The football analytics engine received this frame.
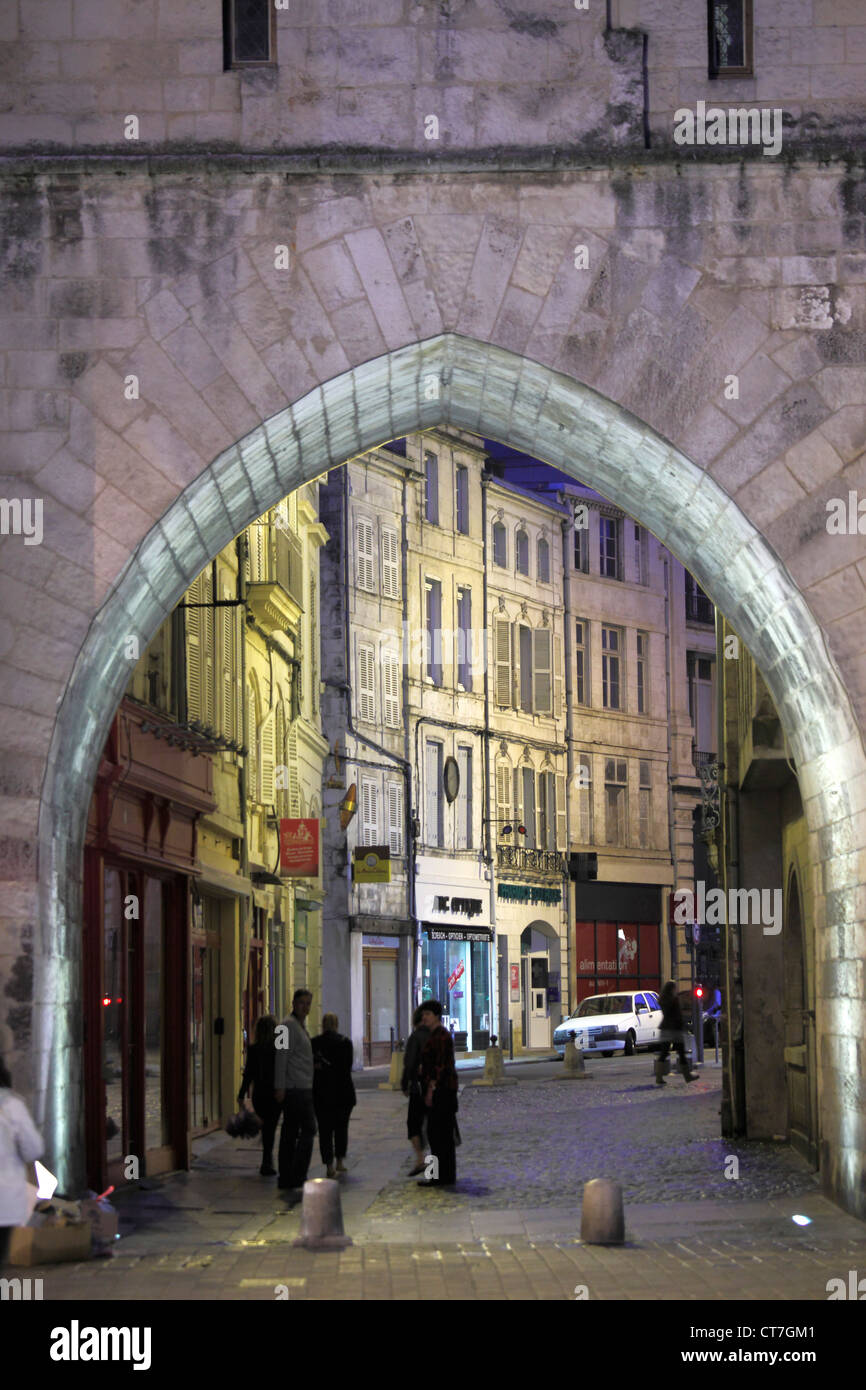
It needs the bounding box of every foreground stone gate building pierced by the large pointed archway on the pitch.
[0,0,866,1213]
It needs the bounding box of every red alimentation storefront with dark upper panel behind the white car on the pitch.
[574,883,662,1006]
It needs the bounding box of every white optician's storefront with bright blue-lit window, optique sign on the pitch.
[416,859,493,1052]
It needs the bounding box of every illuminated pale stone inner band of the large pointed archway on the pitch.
[33,334,866,1209]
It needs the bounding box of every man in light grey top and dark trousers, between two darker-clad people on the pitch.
[274,990,316,1201]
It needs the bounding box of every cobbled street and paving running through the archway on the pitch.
[32,1054,866,1301]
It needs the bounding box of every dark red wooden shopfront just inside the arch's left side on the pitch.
[83,699,215,1191]
